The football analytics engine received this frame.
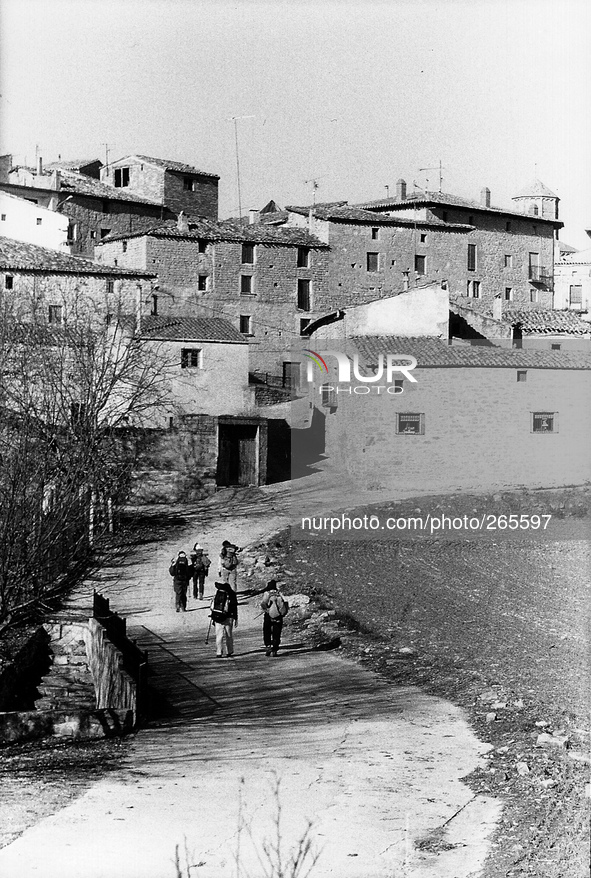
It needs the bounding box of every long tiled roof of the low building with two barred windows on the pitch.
[352,336,591,369]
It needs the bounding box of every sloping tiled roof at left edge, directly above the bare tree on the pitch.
[0,237,156,277]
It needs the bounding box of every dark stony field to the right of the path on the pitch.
[258,489,591,878]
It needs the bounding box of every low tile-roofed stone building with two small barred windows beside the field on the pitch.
[299,336,591,493]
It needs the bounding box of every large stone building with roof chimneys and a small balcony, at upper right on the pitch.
[280,180,562,310]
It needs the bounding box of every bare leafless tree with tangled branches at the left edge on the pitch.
[0,292,168,630]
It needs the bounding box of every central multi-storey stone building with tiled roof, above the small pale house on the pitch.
[96,216,328,384]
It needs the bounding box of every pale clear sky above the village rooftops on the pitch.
[0,0,591,249]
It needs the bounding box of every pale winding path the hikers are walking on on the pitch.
[0,490,500,878]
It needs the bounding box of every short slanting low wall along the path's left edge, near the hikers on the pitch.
[84,619,137,723]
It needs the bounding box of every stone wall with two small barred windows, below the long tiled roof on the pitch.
[324,367,591,492]
